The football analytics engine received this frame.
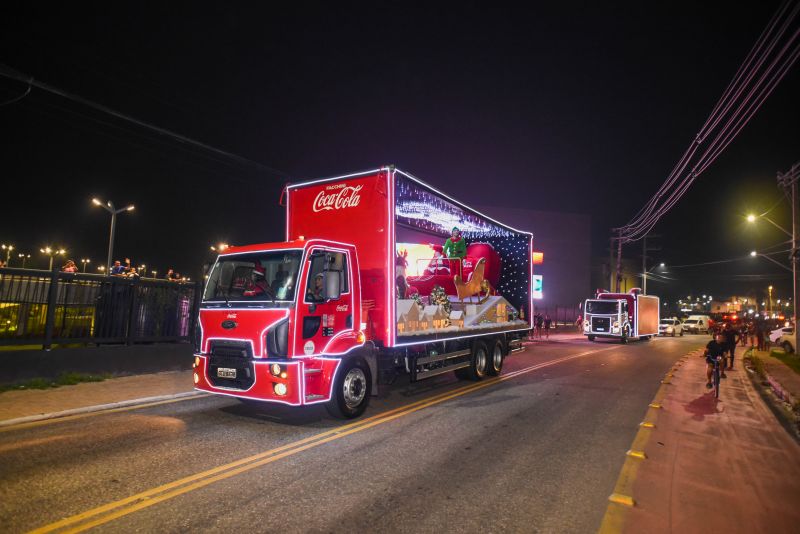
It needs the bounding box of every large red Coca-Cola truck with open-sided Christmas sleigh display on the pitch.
[194,167,532,417]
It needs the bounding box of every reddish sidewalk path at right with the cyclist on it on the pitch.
[604,351,800,534]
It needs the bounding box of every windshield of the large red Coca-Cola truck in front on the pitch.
[203,250,302,302]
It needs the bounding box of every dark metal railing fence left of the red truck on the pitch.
[0,269,202,349]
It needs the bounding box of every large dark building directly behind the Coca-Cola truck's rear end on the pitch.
[477,206,593,318]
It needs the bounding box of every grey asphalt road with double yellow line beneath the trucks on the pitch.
[0,336,706,532]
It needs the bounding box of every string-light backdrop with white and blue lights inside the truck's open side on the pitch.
[395,173,531,315]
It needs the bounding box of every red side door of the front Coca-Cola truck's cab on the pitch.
[294,248,354,356]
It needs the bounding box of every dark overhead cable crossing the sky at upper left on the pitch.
[0,63,290,178]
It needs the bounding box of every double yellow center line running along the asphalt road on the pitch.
[31,347,617,534]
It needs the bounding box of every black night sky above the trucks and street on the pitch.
[0,1,800,306]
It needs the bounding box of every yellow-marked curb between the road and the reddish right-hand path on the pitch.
[598,349,703,534]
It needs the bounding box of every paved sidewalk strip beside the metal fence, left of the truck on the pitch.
[0,371,194,424]
